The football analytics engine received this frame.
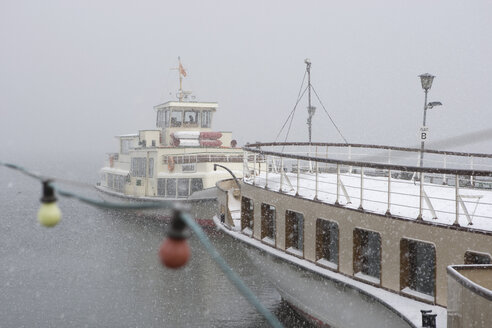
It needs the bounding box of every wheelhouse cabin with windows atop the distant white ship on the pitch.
[154,101,218,146]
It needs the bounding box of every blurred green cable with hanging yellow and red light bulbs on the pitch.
[0,161,283,328]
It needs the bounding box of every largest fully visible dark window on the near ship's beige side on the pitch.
[400,239,436,297]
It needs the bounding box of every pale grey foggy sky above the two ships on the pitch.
[0,0,492,161]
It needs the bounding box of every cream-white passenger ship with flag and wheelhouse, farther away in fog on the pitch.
[98,61,243,200]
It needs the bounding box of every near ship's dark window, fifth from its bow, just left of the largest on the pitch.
[354,229,381,284]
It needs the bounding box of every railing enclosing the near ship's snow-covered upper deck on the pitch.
[243,143,492,230]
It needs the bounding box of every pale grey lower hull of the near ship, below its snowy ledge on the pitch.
[246,246,414,328]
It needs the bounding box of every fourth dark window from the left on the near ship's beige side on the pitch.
[316,219,338,266]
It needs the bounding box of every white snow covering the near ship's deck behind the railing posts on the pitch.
[244,171,492,231]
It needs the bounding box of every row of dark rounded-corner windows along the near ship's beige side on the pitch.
[241,197,491,297]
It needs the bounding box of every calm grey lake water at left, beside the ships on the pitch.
[0,156,310,327]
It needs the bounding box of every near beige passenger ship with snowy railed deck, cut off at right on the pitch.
[214,60,492,328]
